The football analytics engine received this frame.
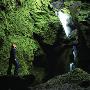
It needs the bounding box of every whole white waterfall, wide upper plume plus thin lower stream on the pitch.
[55,10,77,71]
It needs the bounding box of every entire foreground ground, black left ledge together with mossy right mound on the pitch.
[0,68,90,90]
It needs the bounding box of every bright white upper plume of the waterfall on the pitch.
[55,10,72,37]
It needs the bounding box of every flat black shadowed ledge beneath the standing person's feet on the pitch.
[0,75,35,90]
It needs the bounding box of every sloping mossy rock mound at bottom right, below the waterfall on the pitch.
[29,69,90,90]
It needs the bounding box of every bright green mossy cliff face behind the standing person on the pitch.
[0,0,89,81]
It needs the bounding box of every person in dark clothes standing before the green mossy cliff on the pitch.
[7,44,19,76]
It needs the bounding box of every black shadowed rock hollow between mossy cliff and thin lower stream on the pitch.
[33,31,71,80]
